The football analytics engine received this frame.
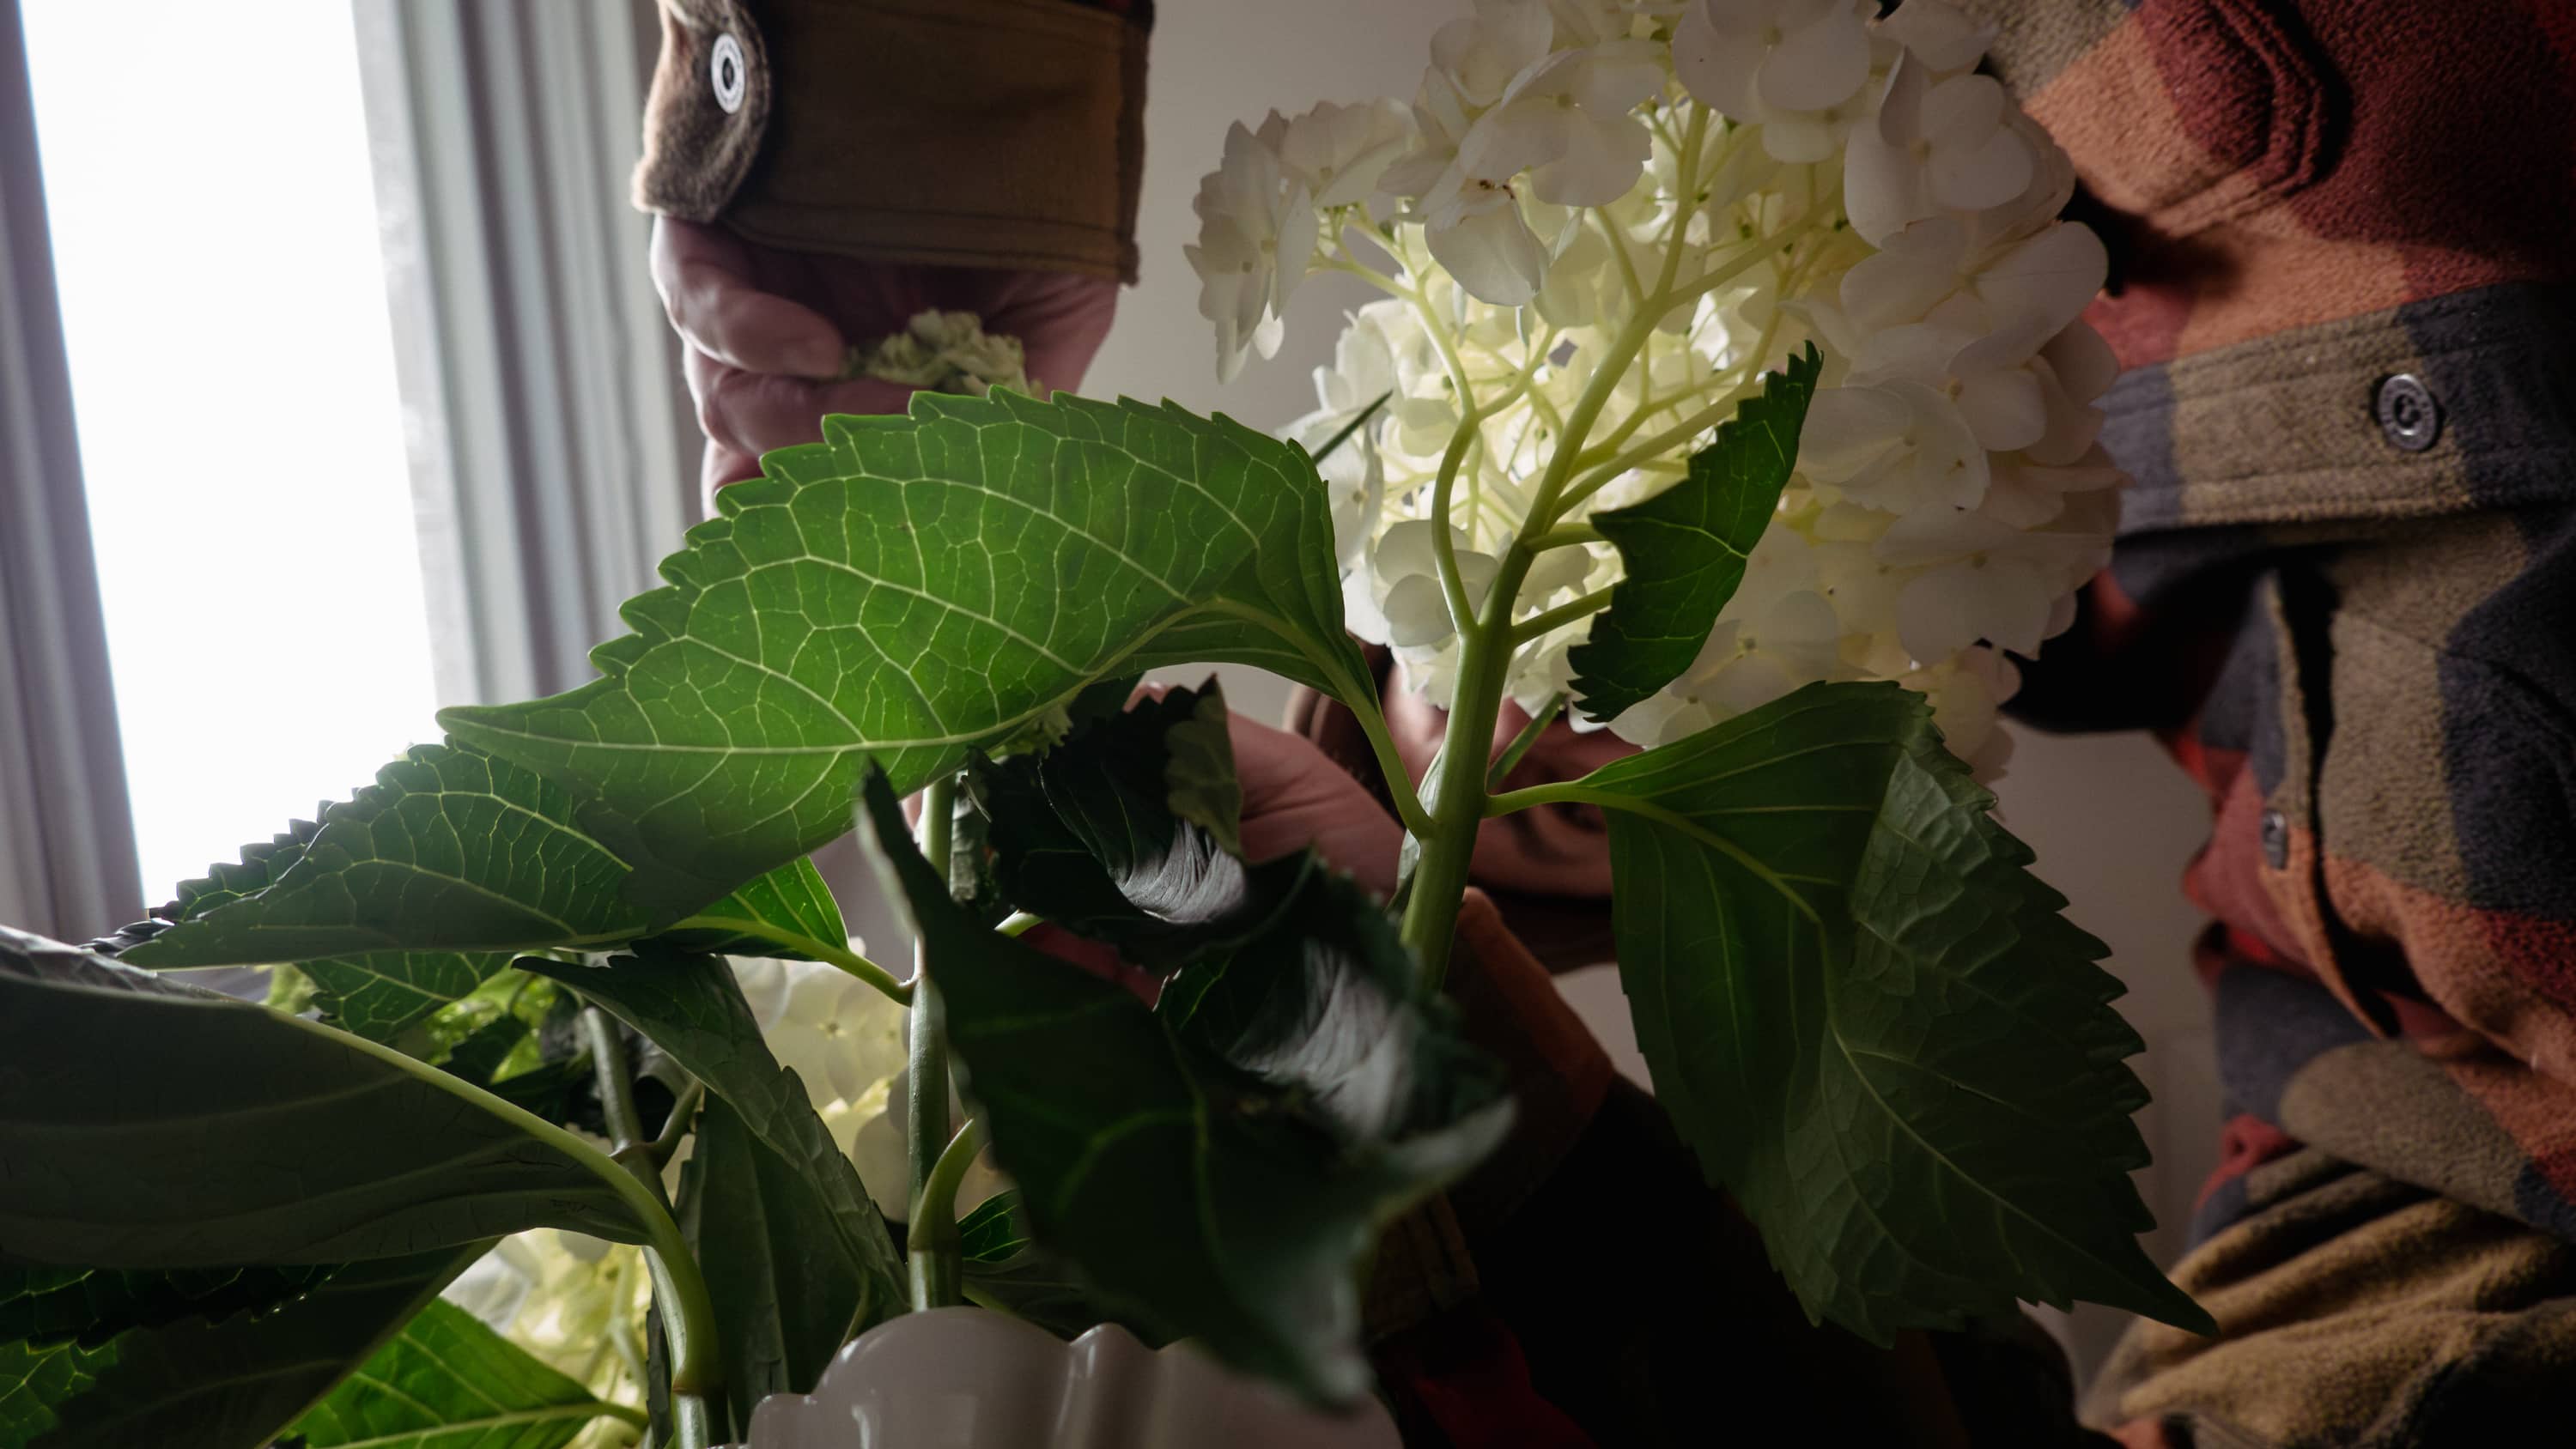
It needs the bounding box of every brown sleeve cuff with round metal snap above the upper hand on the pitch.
[634,0,1151,281]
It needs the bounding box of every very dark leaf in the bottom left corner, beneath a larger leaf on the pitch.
[0,1243,484,1449]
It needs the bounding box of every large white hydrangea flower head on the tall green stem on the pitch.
[1188,0,2123,777]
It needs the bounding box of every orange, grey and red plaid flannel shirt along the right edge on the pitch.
[1971,0,2576,1446]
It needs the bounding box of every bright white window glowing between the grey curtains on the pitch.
[21,0,435,900]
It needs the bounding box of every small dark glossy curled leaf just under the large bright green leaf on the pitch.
[971,685,1309,970]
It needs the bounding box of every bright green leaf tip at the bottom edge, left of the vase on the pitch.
[291,1300,626,1449]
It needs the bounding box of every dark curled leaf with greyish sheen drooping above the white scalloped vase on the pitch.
[866,774,1510,1403]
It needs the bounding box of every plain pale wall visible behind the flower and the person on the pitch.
[1084,0,2218,1361]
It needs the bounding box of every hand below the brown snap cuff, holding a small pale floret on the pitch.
[652,216,1118,500]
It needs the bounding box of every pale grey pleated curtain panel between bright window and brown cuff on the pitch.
[355,0,698,703]
